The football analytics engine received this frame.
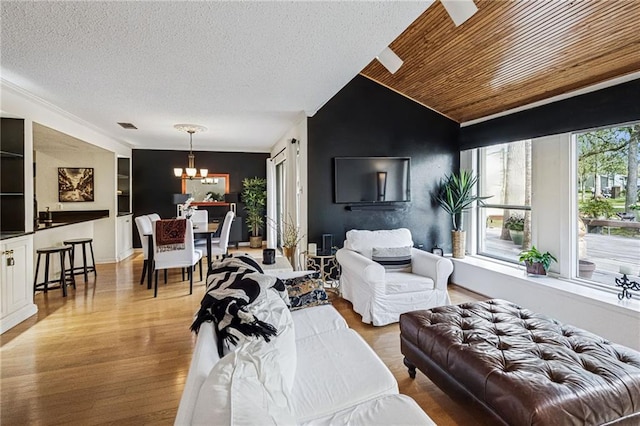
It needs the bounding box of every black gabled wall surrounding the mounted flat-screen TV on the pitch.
[307,75,460,250]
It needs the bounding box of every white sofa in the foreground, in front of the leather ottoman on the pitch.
[175,305,435,426]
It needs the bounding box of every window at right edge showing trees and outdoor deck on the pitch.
[573,123,640,287]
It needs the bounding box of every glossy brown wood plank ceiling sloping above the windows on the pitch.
[361,0,640,123]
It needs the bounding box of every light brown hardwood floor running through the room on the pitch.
[0,250,488,425]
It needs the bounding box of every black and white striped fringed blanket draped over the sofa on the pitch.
[191,256,289,356]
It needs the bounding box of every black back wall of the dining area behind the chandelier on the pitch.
[131,149,269,247]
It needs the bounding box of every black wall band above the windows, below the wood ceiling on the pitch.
[460,79,640,149]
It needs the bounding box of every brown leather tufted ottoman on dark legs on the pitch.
[400,299,640,426]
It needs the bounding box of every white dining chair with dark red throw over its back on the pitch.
[153,219,202,297]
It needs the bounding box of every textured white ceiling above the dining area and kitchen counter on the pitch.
[0,1,432,151]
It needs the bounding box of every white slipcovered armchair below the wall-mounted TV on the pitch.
[336,228,453,325]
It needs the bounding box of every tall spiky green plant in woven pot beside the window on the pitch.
[435,170,489,259]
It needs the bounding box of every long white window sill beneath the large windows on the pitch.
[451,256,640,319]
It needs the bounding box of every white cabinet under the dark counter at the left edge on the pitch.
[0,235,38,333]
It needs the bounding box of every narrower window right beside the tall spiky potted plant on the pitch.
[477,140,531,262]
